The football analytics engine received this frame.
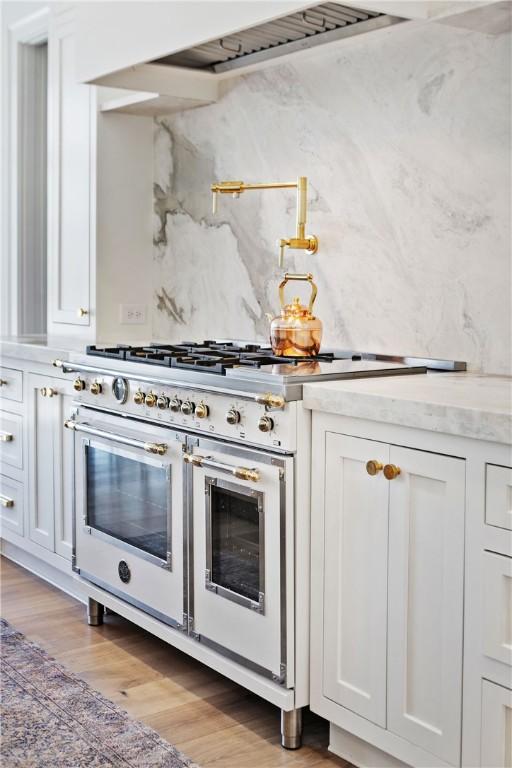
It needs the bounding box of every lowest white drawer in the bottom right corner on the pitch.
[480,680,512,768]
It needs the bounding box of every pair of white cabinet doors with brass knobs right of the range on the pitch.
[311,415,466,766]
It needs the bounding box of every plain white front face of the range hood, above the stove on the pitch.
[77,0,311,83]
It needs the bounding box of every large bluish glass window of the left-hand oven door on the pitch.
[85,445,171,566]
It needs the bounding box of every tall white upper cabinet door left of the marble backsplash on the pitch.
[48,13,92,333]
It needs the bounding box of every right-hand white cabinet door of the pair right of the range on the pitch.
[388,446,465,765]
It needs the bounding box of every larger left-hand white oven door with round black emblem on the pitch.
[67,408,185,626]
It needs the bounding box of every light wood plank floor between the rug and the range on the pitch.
[0,558,348,768]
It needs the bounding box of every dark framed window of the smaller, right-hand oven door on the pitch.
[205,477,265,613]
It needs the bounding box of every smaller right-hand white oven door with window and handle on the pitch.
[184,438,294,687]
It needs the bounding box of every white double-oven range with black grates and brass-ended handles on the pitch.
[55,341,464,748]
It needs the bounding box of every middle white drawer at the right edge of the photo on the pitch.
[482,552,512,666]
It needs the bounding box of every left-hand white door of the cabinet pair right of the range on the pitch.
[323,433,389,727]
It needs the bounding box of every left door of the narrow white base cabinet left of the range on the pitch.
[28,373,55,551]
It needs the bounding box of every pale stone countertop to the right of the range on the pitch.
[304,373,512,444]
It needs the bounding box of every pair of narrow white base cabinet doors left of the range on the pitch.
[27,373,73,559]
